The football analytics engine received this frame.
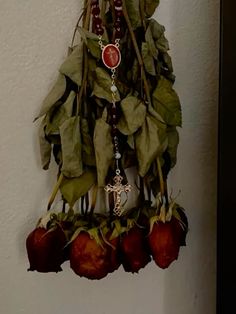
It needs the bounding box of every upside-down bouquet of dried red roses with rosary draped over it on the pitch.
[26,0,188,279]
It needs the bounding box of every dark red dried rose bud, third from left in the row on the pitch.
[121,226,151,273]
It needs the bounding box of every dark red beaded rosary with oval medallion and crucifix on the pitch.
[91,0,131,216]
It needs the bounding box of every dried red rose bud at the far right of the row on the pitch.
[148,217,183,269]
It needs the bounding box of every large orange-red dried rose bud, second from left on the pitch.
[70,231,109,279]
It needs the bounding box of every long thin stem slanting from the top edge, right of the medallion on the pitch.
[123,0,152,105]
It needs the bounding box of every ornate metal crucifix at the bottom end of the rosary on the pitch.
[104,175,131,216]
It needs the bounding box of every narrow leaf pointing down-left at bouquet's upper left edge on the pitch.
[35,74,66,120]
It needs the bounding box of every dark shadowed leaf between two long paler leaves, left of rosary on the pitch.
[80,119,96,166]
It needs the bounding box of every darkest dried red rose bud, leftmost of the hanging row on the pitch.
[26,227,66,273]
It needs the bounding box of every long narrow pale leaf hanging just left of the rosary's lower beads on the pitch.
[94,112,113,187]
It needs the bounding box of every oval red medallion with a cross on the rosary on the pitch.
[102,44,121,69]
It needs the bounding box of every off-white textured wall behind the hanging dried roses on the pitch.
[0,0,219,314]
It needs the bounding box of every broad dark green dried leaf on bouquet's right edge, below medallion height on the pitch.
[152,76,182,126]
